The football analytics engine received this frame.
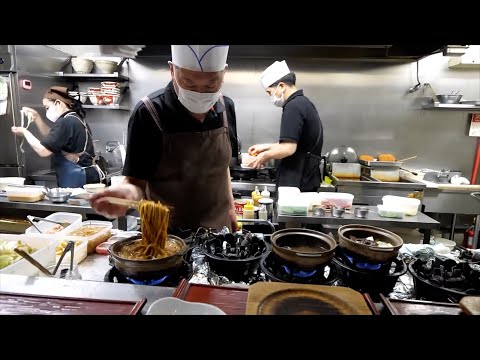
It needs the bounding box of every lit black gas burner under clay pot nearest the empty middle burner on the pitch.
[260,251,338,285]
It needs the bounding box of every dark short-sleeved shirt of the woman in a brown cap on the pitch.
[40,111,99,183]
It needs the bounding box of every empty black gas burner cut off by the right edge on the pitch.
[408,257,480,302]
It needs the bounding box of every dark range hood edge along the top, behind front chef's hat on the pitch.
[134,44,446,62]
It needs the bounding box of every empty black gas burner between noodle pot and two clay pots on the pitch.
[202,234,270,282]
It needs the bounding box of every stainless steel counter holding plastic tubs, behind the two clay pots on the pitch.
[277,206,440,244]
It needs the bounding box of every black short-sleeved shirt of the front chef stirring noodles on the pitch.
[123,81,238,180]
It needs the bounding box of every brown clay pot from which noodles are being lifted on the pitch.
[109,235,188,279]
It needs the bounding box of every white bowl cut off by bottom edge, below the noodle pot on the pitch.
[147,297,226,315]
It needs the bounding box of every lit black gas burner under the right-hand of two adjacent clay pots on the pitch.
[333,253,407,301]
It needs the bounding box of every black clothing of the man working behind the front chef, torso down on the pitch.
[277,90,323,191]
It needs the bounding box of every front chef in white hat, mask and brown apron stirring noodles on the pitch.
[91,45,238,234]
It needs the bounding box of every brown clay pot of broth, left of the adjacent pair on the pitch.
[271,228,337,269]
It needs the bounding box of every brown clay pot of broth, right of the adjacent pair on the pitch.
[338,225,403,263]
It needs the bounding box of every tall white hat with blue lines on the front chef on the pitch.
[172,45,228,72]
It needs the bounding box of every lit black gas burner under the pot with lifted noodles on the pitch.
[103,261,193,287]
